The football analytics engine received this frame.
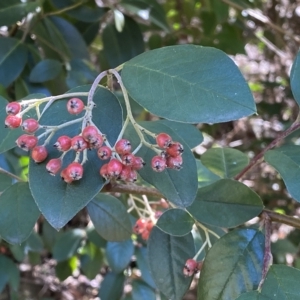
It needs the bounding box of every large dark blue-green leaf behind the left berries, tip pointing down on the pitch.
[29,86,122,229]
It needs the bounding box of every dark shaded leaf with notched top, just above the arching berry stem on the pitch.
[102,17,145,68]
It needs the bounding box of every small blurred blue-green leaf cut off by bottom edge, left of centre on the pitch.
[99,272,125,300]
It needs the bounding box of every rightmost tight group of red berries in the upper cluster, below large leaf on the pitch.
[151,133,183,172]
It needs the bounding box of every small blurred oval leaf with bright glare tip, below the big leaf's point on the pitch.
[52,228,86,262]
